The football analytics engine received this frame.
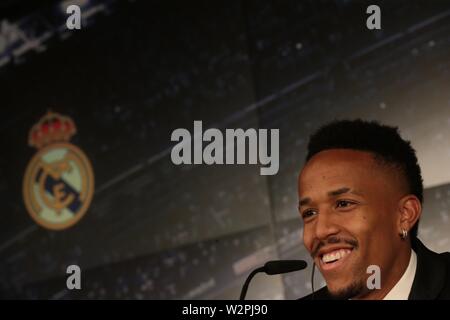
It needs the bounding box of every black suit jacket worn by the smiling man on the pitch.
[301,239,450,300]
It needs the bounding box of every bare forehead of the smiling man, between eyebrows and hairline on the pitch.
[298,149,389,194]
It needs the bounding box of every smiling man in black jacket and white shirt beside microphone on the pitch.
[298,120,450,300]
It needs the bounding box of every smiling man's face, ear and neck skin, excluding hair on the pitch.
[298,149,422,299]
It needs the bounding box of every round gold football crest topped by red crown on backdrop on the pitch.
[23,112,94,230]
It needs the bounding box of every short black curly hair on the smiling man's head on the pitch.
[306,119,423,238]
